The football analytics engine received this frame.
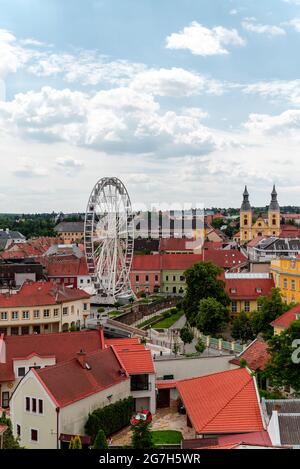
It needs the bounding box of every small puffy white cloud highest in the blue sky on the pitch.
[166,21,246,56]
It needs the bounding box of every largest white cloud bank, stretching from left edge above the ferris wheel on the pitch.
[0,87,235,156]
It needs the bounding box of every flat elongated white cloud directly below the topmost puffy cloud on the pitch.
[130,67,223,97]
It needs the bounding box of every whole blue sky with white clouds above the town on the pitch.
[0,0,300,212]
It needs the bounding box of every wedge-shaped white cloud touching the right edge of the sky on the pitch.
[242,79,300,106]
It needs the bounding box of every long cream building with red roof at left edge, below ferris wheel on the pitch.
[0,282,90,335]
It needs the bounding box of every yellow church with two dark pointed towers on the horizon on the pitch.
[240,185,280,244]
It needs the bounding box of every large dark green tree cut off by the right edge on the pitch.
[264,320,300,393]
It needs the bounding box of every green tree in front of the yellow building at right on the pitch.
[251,288,291,339]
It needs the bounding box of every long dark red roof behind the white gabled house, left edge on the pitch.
[0,331,101,382]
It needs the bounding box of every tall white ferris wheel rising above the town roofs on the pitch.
[84,177,134,303]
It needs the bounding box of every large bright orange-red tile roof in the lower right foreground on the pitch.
[177,368,264,434]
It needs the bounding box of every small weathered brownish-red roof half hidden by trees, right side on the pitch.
[230,338,270,371]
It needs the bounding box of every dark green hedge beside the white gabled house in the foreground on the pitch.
[85,396,134,442]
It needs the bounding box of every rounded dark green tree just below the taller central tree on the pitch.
[196,298,229,335]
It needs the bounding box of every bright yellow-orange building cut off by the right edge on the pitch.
[270,257,300,303]
